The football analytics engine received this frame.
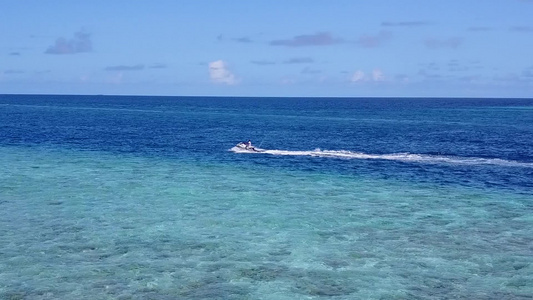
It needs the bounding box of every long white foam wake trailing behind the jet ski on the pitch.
[230,147,533,168]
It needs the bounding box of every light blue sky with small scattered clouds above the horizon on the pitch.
[0,0,533,98]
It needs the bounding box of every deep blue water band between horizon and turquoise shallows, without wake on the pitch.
[0,95,533,191]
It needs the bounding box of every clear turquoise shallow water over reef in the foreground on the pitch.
[0,146,533,299]
